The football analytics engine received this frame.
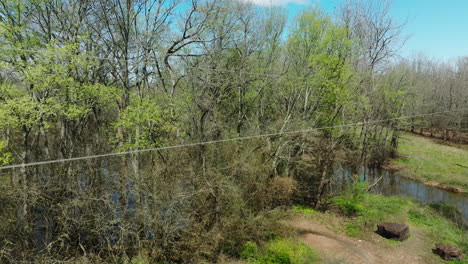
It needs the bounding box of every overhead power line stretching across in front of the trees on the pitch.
[0,109,464,170]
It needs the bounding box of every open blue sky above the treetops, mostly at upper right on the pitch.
[244,0,468,60]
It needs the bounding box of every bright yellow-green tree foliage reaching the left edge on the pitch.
[0,43,120,134]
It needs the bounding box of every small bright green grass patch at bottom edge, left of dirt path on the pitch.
[241,238,318,264]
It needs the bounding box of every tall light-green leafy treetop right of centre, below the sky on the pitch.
[288,8,363,128]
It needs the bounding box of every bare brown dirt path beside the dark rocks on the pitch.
[287,217,440,264]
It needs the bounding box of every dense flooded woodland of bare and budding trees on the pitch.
[0,0,468,263]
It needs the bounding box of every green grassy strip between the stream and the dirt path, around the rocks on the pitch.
[294,185,468,256]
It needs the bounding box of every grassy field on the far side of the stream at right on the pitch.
[393,133,468,191]
